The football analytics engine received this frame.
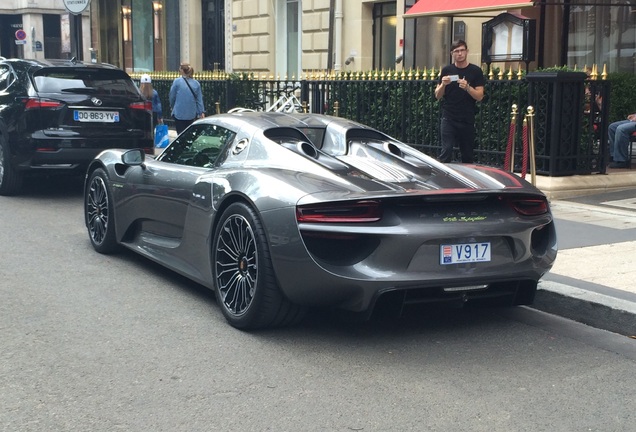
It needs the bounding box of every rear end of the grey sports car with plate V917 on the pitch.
[277,192,556,311]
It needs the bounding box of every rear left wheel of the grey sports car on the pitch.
[213,203,304,330]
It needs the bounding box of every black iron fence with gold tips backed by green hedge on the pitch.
[139,71,610,176]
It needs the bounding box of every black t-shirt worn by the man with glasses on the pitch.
[440,63,486,123]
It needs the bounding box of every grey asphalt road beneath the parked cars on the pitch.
[0,176,636,432]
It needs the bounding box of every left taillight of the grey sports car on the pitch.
[296,200,382,223]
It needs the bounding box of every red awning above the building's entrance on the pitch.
[404,0,534,18]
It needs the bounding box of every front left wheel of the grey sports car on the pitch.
[84,168,119,254]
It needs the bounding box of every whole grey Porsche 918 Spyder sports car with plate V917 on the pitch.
[84,112,557,329]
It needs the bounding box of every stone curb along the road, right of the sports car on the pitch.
[530,281,636,337]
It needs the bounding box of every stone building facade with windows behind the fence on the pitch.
[0,0,636,78]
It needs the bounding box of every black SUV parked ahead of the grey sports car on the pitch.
[0,57,154,195]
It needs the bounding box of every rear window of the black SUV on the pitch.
[33,68,139,96]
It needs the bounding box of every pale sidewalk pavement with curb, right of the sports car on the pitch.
[532,176,636,338]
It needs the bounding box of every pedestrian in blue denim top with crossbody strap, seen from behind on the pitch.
[170,63,205,134]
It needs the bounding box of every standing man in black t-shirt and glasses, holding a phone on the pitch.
[435,40,486,163]
